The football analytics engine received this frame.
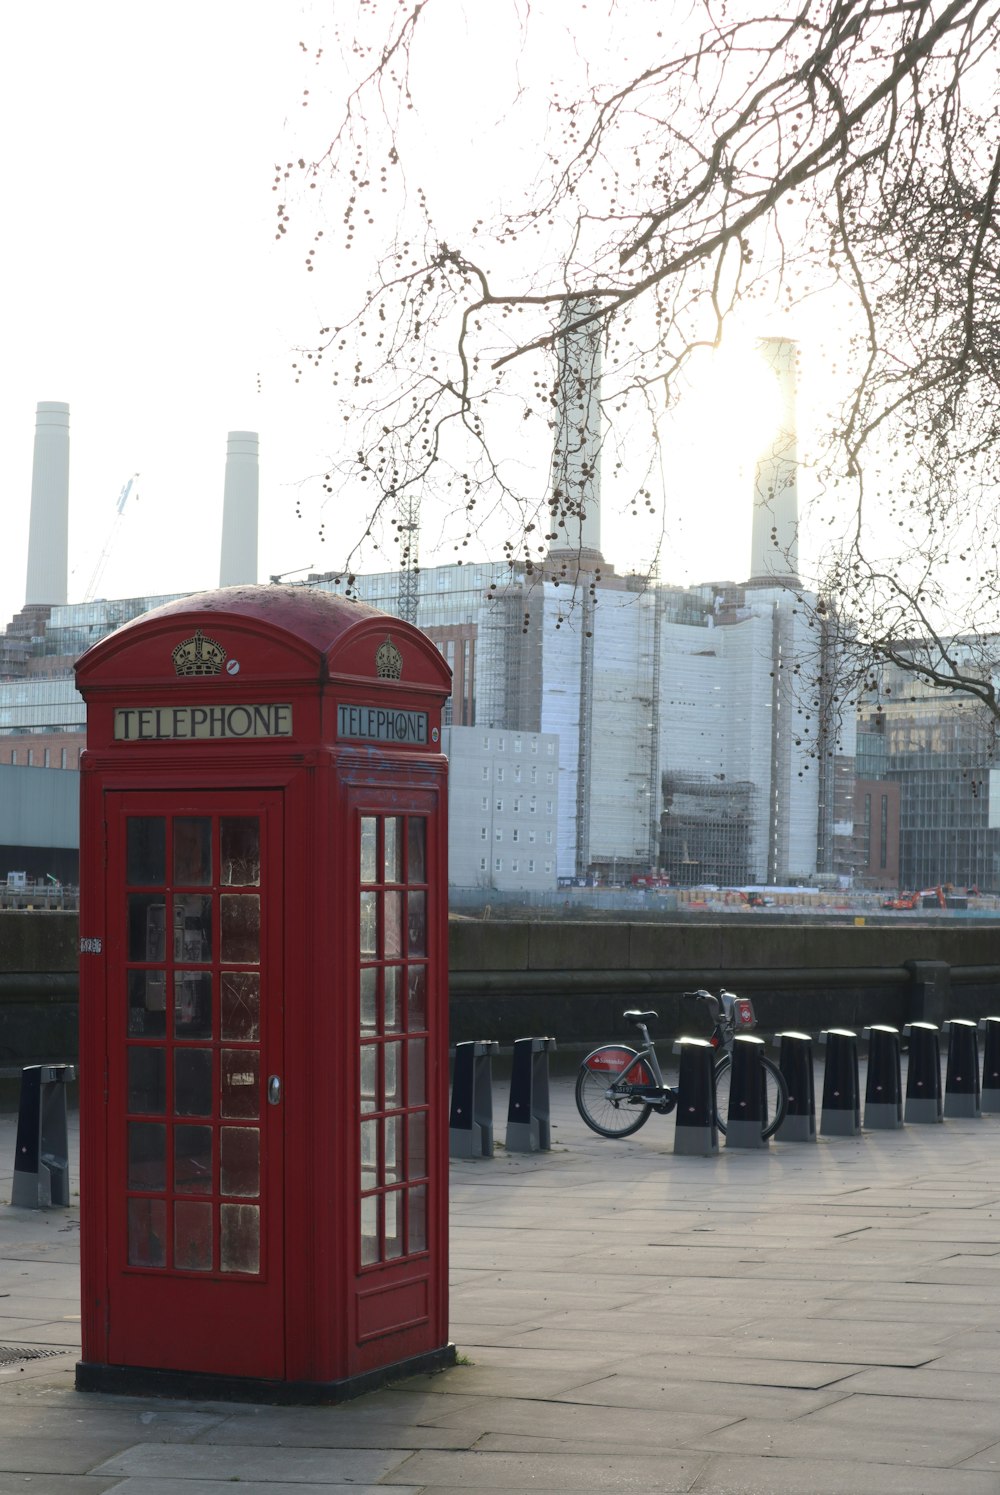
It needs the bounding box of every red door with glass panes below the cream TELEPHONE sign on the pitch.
[105,789,284,1378]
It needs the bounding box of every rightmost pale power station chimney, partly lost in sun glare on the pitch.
[750,338,800,588]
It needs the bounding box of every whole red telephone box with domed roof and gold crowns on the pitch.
[76,586,454,1401]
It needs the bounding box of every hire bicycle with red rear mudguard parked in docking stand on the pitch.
[575,988,788,1138]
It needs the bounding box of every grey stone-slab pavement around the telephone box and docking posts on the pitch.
[0,1079,1000,1495]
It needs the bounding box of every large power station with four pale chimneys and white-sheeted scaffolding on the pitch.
[0,346,855,888]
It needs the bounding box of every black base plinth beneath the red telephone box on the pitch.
[76,1344,456,1407]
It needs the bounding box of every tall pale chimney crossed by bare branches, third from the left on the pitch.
[549,296,604,559]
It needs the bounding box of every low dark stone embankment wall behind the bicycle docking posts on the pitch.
[0,912,1000,1073]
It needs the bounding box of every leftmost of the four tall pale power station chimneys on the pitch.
[24,399,69,605]
